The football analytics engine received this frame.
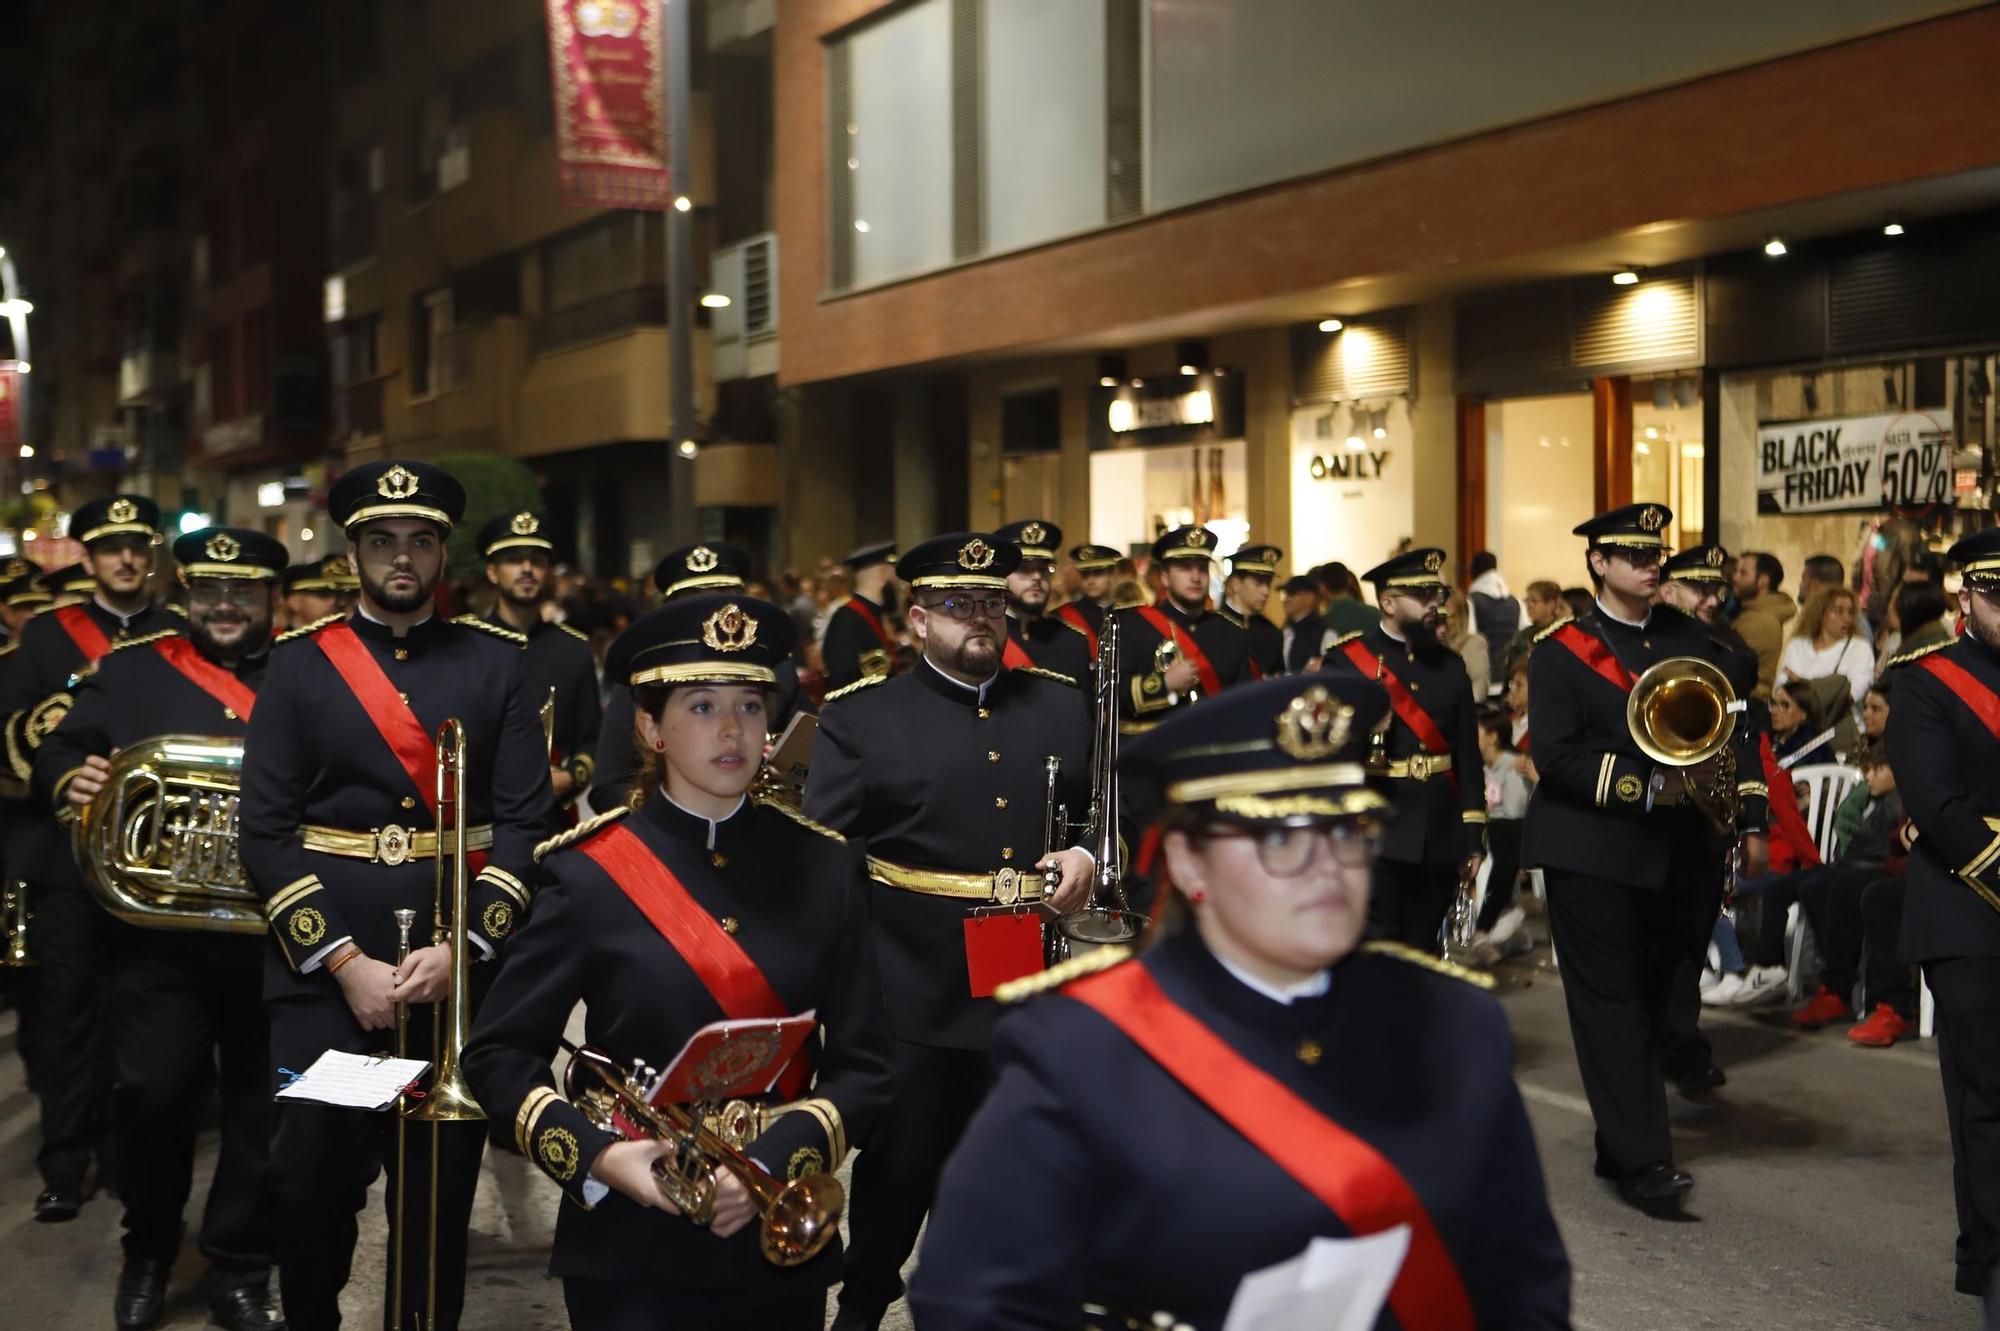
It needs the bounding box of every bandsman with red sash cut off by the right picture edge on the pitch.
[1880,528,2000,1295]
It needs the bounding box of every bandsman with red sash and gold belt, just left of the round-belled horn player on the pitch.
[1326,548,1486,953]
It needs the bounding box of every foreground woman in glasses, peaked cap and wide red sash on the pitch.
[912,673,1570,1331]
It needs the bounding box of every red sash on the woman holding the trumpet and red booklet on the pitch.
[576,825,810,1099]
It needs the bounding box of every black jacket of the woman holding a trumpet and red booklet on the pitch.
[464,791,892,1293]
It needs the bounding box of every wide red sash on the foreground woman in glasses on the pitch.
[1064,965,1474,1331]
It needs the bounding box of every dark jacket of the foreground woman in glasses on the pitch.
[910,929,1570,1331]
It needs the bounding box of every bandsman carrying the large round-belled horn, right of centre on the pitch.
[1522,504,1764,1213]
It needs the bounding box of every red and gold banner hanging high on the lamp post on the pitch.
[546,0,672,212]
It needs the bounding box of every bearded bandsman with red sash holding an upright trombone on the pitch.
[240,462,556,1331]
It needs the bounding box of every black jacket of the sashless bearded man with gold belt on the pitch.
[806,662,1090,1049]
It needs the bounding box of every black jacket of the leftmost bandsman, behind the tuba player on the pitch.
[0,598,182,889]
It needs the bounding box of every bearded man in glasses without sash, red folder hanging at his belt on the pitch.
[806,532,1092,1329]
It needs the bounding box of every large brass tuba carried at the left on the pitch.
[70,735,264,933]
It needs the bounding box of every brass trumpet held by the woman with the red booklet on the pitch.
[562,1041,846,1267]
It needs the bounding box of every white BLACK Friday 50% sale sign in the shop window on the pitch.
[1756,412,1952,514]
